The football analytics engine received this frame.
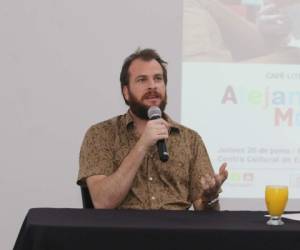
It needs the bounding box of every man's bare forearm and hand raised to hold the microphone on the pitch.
[86,119,168,208]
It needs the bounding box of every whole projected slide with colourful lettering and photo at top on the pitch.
[181,0,300,198]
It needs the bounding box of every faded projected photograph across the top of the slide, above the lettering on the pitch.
[183,0,300,64]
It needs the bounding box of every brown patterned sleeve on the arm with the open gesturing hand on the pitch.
[190,133,214,202]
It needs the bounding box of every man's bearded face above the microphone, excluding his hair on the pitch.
[123,59,167,120]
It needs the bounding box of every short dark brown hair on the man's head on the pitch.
[120,49,168,105]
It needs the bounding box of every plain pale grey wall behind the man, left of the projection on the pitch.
[0,0,182,249]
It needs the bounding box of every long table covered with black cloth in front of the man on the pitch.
[14,208,300,250]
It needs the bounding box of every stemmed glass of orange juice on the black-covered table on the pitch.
[265,185,289,226]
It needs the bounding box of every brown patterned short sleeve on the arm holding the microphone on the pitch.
[77,126,113,186]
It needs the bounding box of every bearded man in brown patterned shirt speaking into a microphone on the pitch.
[78,49,228,210]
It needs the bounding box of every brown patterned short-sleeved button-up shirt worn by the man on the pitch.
[77,112,213,210]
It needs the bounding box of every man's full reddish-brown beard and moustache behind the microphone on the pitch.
[128,90,167,120]
